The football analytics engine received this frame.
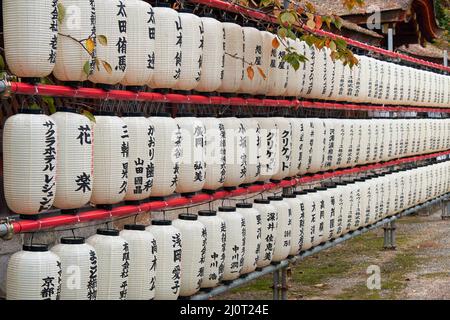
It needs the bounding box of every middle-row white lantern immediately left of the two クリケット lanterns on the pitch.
[240,117,261,184]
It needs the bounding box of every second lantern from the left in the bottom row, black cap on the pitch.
[52,237,98,300]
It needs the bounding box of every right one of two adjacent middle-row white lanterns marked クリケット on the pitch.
[272,117,292,180]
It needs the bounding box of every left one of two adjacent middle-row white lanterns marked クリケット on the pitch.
[256,117,279,181]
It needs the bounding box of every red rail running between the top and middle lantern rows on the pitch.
[10,82,450,113]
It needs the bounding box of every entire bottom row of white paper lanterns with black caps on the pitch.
[7,161,450,299]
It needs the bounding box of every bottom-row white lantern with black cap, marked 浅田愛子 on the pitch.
[146,220,182,300]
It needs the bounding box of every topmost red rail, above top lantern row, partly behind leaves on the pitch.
[189,0,450,72]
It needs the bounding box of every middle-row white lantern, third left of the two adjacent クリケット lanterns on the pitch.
[199,114,227,190]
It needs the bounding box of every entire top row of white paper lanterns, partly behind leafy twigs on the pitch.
[3,0,450,107]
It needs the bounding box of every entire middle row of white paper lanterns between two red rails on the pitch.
[3,109,450,214]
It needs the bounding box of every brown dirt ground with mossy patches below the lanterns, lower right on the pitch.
[218,205,450,300]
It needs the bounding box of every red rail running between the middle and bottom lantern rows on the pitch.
[12,150,450,233]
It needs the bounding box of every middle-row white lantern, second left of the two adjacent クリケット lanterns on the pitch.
[222,117,248,188]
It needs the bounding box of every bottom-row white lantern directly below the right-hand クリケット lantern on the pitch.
[267,196,292,262]
